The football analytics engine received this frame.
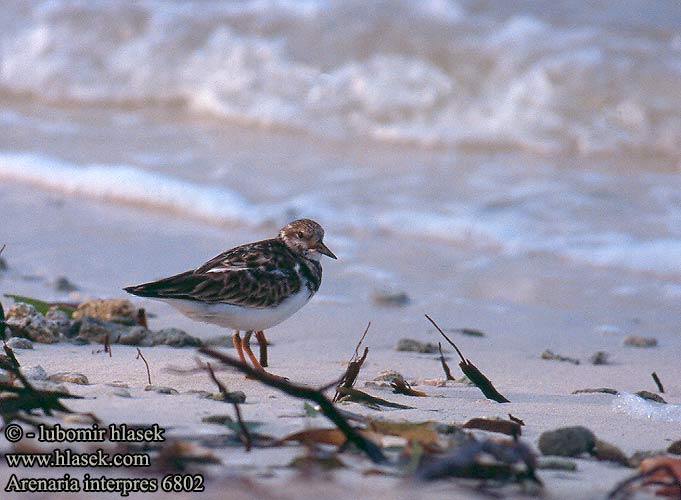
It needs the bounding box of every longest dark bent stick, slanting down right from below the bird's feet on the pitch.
[199,347,387,463]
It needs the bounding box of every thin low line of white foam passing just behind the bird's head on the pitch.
[0,152,681,277]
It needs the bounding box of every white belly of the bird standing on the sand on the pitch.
[158,287,310,331]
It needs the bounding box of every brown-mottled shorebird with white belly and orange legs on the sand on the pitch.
[124,219,337,376]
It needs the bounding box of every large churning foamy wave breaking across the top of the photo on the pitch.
[0,0,681,154]
